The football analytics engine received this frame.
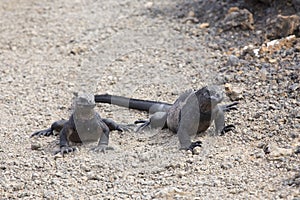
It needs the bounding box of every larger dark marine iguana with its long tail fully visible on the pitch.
[95,86,238,151]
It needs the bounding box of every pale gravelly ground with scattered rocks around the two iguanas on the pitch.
[0,0,300,200]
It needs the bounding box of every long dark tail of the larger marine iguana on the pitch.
[95,94,172,113]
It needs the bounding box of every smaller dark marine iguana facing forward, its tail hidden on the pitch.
[31,94,127,155]
